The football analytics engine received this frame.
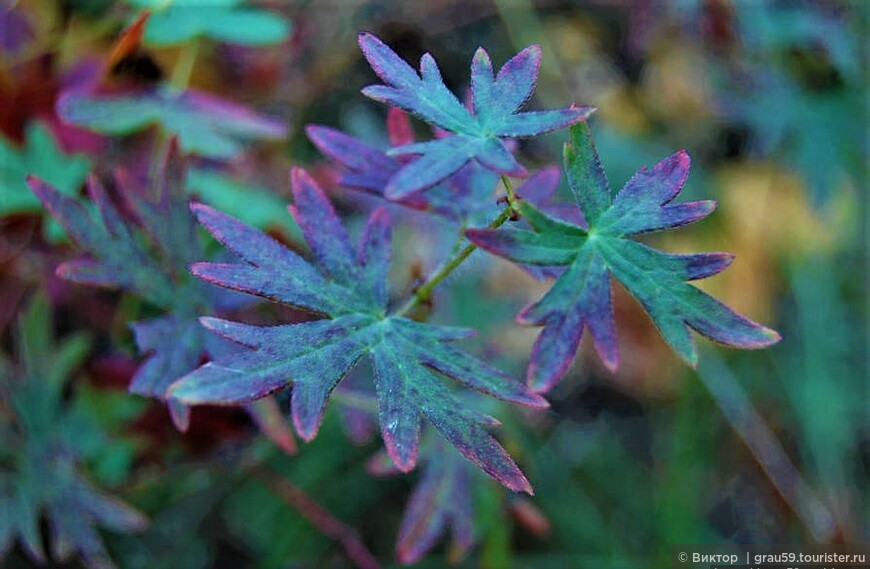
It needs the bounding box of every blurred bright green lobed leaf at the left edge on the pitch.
[0,122,91,237]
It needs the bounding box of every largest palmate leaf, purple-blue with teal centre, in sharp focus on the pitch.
[170,169,546,492]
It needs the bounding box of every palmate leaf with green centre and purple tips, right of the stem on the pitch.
[467,125,779,392]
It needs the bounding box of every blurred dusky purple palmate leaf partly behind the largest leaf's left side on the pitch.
[28,139,292,449]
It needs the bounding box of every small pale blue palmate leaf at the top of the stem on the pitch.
[359,33,594,199]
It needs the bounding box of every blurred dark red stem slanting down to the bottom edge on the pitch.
[258,470,380,569]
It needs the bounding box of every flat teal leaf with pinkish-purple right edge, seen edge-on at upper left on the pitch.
[57,87,287,159]
